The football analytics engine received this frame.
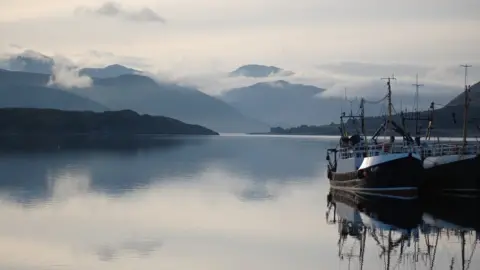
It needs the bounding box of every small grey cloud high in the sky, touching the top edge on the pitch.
[75,2,166,23]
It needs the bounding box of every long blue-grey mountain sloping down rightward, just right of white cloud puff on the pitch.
[73,74,269,132]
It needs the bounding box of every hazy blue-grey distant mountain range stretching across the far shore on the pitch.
[0,51,474,132]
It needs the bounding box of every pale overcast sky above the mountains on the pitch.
[0,0,480,95]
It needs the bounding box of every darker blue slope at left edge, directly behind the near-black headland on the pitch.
[0,70,108,112]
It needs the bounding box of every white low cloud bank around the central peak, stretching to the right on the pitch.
[149,61,480,113]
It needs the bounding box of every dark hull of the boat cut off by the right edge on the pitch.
[422,155,480,198]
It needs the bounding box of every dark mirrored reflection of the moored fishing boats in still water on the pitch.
[326,190,480,270]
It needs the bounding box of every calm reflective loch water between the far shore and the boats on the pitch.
[0,136,480,270]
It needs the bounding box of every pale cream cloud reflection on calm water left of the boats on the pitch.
[0,170,335,269]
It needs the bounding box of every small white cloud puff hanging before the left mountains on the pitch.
[48,56,93,88]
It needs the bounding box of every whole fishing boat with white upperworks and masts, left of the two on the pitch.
[327,77,423,199]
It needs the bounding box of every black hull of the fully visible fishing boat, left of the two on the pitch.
[330,155,423,199]
